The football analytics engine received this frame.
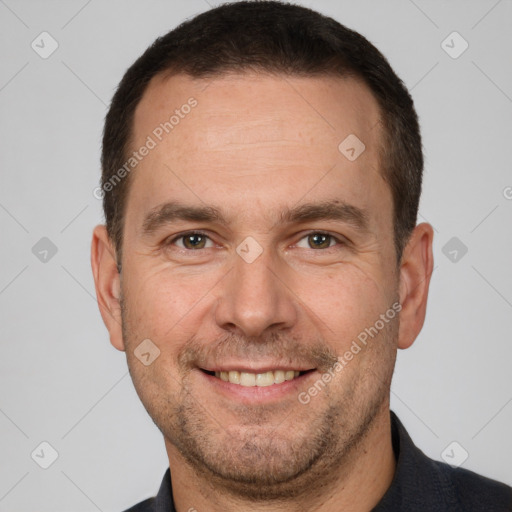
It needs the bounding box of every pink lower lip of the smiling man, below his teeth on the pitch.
[197,370,316,403]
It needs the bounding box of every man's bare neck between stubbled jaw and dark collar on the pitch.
[165,403,396,512]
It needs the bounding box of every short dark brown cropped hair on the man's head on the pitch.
[101,1,423,266]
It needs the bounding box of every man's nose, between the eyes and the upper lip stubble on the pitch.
[215,244,297,337]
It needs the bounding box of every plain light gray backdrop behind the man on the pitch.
[0,0,512,512]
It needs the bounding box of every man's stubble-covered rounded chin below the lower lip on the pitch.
[163,402,348,501]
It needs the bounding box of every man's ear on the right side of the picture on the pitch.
[398,222,434,349]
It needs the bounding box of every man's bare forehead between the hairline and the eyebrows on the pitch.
[127,73,389,231]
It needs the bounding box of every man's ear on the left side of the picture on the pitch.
[91,225,125,351]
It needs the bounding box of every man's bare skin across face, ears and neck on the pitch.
[91,74,433,512]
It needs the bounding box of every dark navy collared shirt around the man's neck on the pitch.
[126,411,512,512]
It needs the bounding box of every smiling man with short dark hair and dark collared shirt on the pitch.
[92,2,512,512]
